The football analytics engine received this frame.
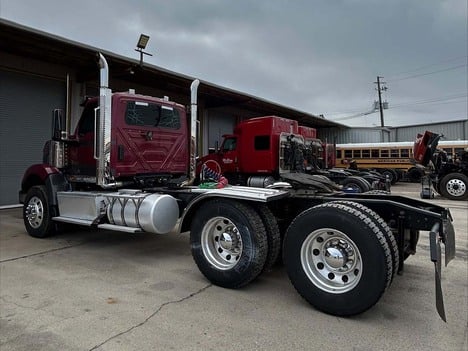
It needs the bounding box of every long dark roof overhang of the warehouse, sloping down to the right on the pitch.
[0,19,348,128]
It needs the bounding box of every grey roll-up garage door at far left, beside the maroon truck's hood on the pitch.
[0,70,66,206]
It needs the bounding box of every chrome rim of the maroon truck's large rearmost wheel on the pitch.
[301,228,362,294]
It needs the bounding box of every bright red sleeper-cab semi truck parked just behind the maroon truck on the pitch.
[197,116,390,192]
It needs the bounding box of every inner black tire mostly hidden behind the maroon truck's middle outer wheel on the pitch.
[255,204,281,272]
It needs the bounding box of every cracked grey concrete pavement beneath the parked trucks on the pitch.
[0,183,468,351]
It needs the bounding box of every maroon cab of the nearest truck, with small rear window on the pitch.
[45,91,189,186]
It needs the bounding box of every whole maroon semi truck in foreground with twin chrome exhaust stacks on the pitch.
[19,54,455,320]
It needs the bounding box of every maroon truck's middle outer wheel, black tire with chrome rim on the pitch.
[190,199,268,289]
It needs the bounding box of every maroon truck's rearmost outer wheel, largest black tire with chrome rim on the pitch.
[283,202,393,316]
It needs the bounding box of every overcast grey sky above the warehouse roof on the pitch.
[0,0,468,127]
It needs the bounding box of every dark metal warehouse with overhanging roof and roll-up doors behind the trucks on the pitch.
[0,19,347,206]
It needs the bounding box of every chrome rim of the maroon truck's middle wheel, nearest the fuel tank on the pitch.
[201,216,243,270]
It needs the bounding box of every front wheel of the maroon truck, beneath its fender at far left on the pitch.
[23,185,56,238]
